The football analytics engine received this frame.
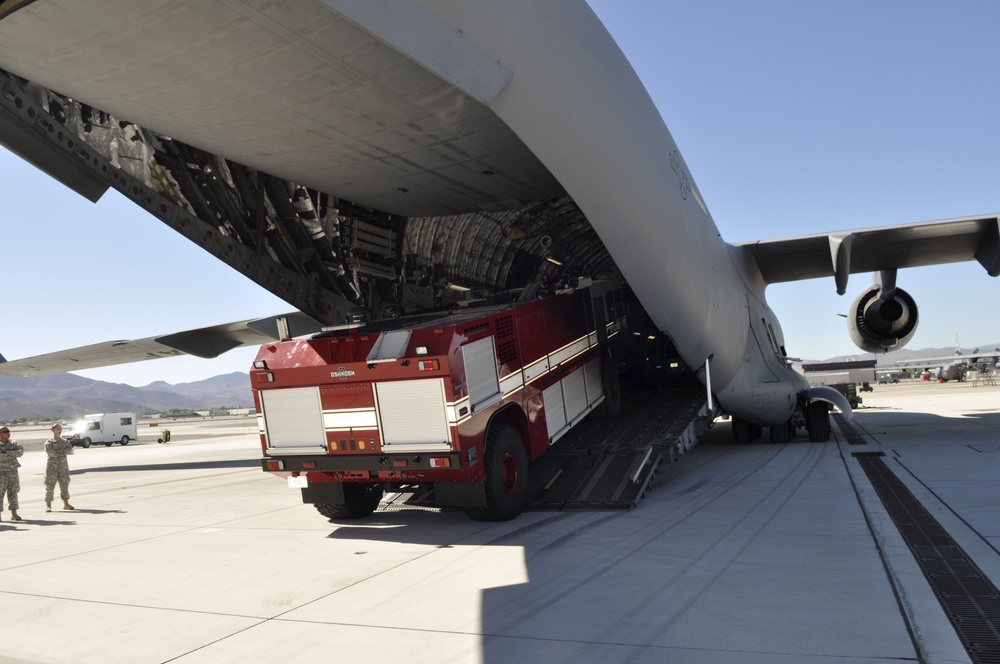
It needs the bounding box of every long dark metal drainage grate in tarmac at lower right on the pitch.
[852,452,1000,664]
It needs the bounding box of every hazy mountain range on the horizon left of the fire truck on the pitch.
[0,371,253,420]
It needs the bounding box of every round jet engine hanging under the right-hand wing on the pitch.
[847,284,917,353]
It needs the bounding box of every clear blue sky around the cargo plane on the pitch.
[0,0,1000,385]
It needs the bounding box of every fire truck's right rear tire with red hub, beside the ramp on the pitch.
[465,424,528,521]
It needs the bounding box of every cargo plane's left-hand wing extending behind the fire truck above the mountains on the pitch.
[0,312,321,376]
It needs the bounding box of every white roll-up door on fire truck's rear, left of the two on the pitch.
[260,387,327,454]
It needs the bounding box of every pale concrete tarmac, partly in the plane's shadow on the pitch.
[0,383,1000,664]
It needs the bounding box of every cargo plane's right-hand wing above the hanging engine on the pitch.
[737,215,1000,295]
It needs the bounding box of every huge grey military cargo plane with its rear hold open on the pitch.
[0,0,1000,442]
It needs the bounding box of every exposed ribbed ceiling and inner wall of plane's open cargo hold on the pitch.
[0,70,618,324]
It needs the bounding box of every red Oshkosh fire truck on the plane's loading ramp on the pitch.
[251,279,625,520]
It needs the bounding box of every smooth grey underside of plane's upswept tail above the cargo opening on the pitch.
[0,0,563,216]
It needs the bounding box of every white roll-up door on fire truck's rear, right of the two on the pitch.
[375,378,451,452]
